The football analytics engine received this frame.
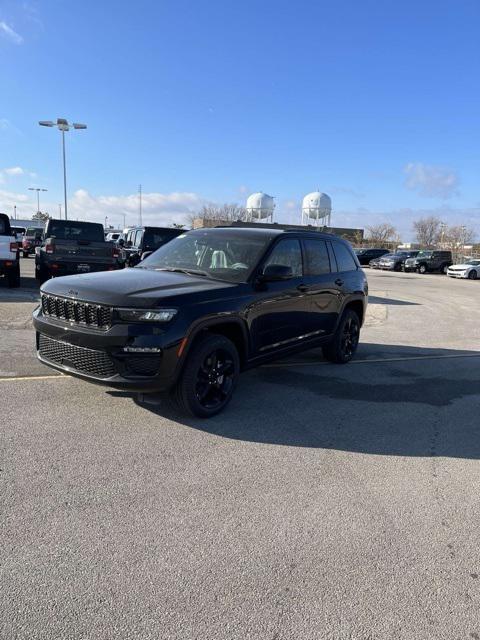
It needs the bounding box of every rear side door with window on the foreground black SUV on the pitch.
[302,238,342,337]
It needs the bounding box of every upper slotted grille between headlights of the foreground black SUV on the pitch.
[42,293,112,330]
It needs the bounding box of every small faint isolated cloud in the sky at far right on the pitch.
[404,162,459,199]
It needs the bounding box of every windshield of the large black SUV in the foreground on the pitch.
[139,229,270,282]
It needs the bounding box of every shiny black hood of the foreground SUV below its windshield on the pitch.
[41,268,238,307]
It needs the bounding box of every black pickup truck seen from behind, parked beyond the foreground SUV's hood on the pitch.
[35,220,120,283]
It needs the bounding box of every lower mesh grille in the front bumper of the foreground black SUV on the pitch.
[38,334,116,378]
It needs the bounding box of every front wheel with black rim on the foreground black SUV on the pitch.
[174,334,240,418]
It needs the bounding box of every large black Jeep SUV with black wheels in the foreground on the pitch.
[33,227,368,417]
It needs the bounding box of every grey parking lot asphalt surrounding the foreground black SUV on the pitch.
[0,259,480,640]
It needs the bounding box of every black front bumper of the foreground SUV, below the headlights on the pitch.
[33,308,183,391]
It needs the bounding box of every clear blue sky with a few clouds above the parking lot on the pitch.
[0,0,480,237]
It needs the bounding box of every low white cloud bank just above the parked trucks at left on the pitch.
[68,189,206,226]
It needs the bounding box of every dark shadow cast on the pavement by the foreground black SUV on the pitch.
[115,344,480,459]
